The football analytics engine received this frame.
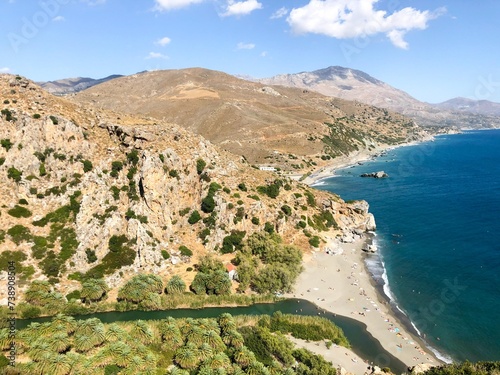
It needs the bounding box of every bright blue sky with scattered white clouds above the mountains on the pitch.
[0,0,500,103]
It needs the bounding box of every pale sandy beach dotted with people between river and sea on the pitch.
[287,240,442,374]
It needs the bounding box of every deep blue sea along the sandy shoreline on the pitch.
[317,130,500,361]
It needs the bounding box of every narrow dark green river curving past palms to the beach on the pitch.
[17,299,408,373]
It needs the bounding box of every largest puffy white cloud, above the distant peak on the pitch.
[287,0,446,49]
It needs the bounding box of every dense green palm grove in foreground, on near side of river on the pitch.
[0,313,349,375]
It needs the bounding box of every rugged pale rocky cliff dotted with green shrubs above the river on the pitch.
[0,75,375,299]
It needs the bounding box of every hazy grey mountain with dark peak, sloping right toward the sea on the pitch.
[258,66,500,128]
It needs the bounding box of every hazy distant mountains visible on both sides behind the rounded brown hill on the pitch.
[39,66,500,128]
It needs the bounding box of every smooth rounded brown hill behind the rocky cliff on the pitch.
[70,68,424,173]
